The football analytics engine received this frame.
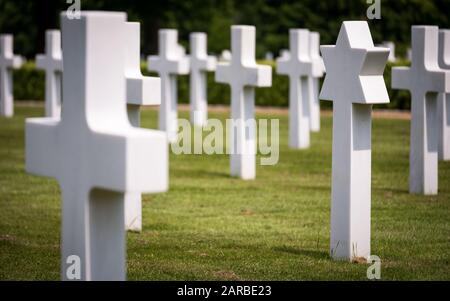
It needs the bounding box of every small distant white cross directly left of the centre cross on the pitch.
[189,32,216,126]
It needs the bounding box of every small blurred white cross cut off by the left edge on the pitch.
[0,34,22,117]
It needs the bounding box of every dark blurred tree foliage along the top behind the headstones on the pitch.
[0,0,450,58]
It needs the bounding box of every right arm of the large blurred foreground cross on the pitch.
[89,128,168,193]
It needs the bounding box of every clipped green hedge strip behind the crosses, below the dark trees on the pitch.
[14,62,410,110]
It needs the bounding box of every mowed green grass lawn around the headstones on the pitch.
[0,107,450,280]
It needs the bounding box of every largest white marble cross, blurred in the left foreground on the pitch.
[25,12,168,280]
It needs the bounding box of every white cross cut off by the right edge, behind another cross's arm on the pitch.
[438,29,450,161]
